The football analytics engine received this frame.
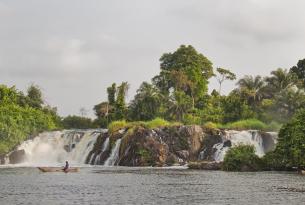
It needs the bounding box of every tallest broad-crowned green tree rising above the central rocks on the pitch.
[153,45,213,104]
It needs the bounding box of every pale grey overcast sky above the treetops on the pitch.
[0,0,305,117]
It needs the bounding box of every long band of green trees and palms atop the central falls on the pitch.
[94,45,305,131]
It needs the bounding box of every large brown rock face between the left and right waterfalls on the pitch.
[119,126,204,166]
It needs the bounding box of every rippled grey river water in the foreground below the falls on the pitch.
[0,166,305,205]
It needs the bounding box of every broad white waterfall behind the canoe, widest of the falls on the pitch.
[8,130,103,166]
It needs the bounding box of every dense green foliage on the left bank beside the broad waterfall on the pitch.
[0,85,60,155]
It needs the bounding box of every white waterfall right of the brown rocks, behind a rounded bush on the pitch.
[213,130,277,162]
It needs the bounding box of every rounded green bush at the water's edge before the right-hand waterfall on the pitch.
[222,144,263,171]
